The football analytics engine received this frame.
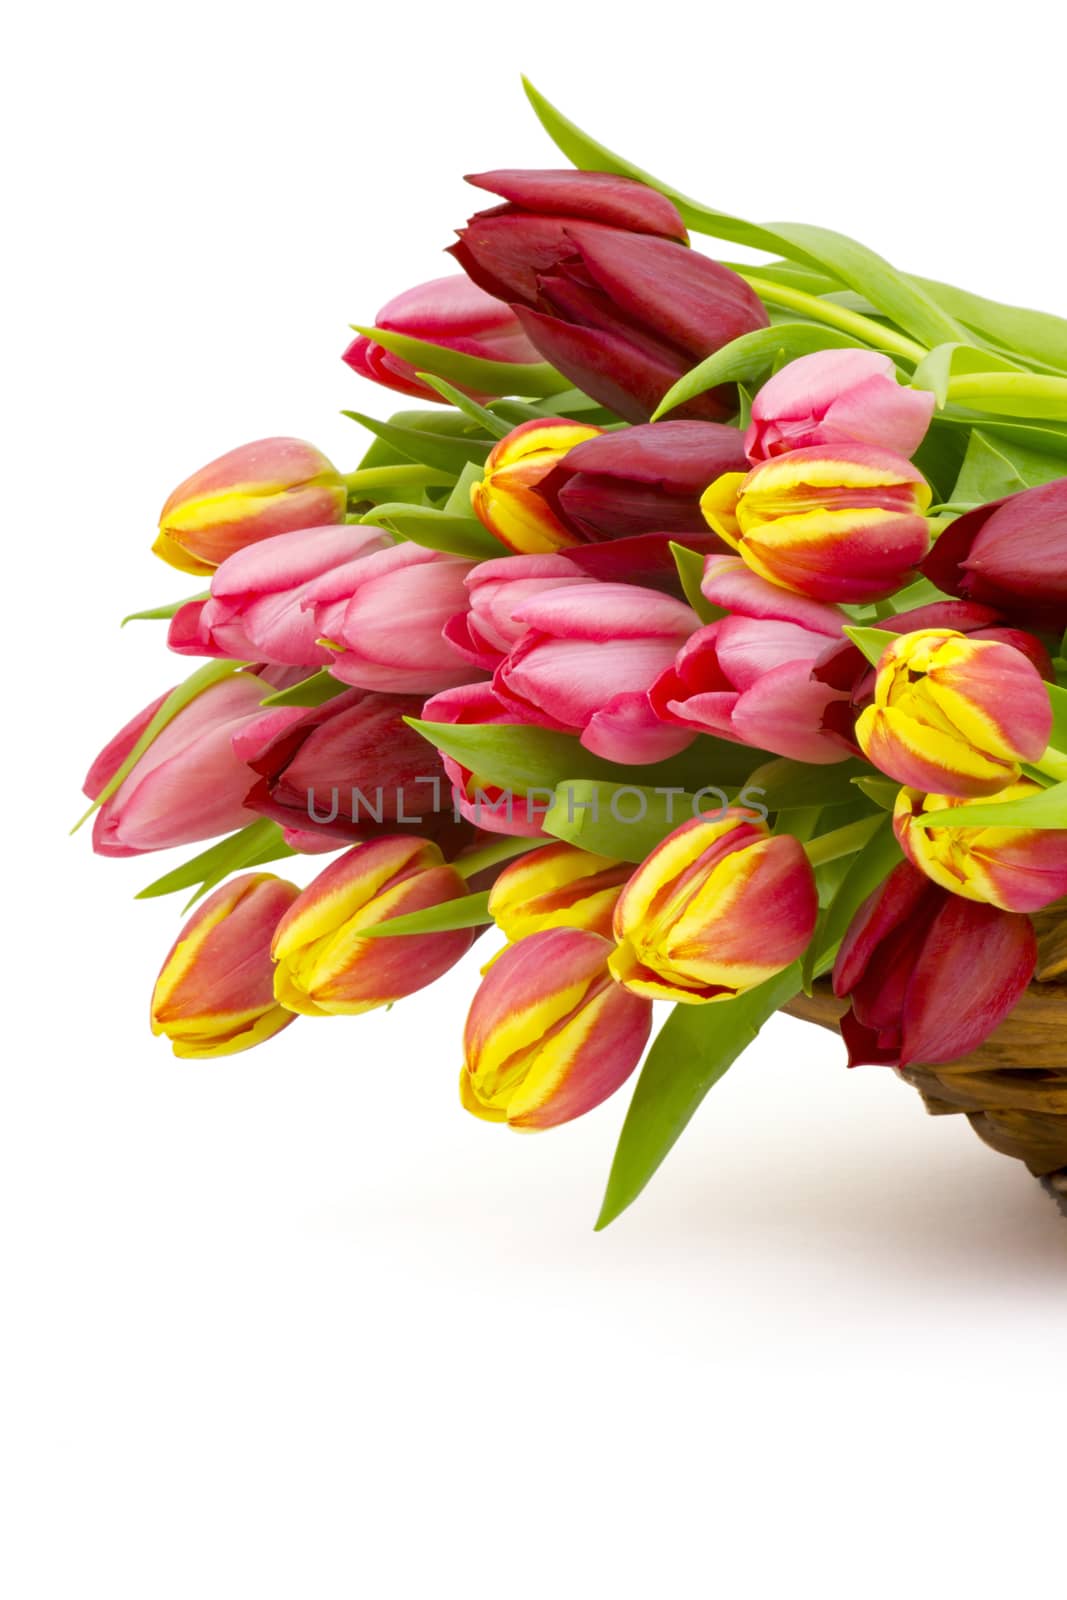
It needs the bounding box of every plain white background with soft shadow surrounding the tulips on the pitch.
[0,0,1067,1600]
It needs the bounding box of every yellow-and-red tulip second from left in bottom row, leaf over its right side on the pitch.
[272,835,474,1016]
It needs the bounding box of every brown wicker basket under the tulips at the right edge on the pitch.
[785,907,1067,1213]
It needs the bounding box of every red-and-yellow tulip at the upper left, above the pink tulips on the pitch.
[152,438,347,573]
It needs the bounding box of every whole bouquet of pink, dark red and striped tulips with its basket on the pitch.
[77,90,1067,1221]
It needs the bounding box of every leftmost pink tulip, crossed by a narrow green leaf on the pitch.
[85,672,299,856]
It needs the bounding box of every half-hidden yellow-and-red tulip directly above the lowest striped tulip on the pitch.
[490,843,633,941]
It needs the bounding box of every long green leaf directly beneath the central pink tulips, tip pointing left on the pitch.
[406,717,769,800]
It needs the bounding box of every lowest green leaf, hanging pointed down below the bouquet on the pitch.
[597,963,800,1229]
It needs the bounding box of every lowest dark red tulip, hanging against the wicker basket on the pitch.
[833,861,1037,1067]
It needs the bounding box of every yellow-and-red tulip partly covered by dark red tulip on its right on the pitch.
[470,418,603,555]
